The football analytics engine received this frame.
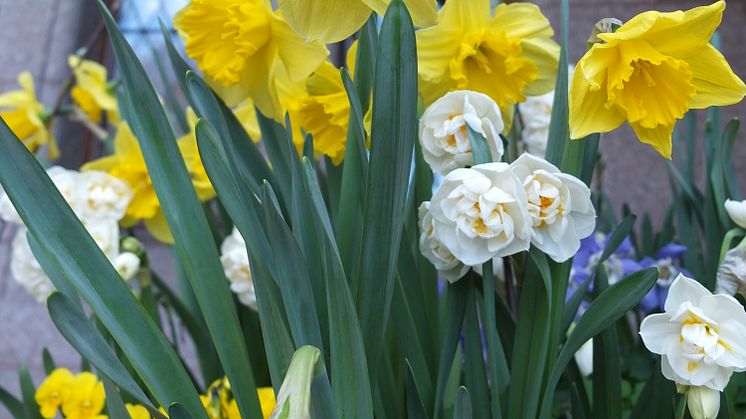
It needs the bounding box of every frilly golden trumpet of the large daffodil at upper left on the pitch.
[175,0,270,86]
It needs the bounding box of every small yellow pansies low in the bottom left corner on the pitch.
[34,368,106,419]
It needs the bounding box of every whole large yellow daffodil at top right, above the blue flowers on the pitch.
[570,1,746,159]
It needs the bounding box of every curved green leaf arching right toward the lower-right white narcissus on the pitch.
[539,268,658,418]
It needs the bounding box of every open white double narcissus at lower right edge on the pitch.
[640,274,746,391]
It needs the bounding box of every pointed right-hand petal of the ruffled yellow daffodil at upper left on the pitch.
[268,13,326,81]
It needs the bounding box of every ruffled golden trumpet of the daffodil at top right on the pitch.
[606,45,695,128]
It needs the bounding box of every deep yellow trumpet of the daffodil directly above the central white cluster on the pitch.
[450,28,539,106]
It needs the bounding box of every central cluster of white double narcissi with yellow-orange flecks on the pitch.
[419,91,596,281]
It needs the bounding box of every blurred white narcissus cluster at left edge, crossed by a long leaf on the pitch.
[0,166,140,302]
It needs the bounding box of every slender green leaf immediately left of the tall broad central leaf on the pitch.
[303,159,373,418]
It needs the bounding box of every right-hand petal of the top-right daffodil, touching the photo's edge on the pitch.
[686,44,746,109]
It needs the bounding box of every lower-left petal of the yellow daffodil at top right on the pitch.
[570,68,624,139]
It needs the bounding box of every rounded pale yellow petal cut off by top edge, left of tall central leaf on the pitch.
[280,0,371,43]
